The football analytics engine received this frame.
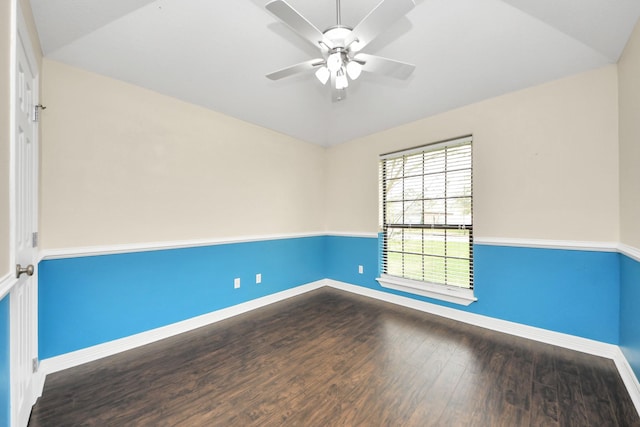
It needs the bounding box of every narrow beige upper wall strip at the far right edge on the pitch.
[618,18,640,248]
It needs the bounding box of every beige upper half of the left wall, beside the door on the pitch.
[41,59,325,249]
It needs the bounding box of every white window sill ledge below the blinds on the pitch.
[376,274,478,305]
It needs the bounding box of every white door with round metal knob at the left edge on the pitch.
[10,2,38,427]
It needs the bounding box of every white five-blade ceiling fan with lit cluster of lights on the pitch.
[265,0,415,102]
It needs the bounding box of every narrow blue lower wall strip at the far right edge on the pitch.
[620,255,640,378]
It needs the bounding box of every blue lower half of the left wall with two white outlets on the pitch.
[38,236,325,359]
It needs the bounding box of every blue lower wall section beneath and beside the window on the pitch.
[327,236,620,344]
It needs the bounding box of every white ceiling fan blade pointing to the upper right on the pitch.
[344,0,416,50]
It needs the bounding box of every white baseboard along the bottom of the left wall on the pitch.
[40,280,325,380]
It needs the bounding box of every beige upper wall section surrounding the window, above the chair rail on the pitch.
[326,66,619,242]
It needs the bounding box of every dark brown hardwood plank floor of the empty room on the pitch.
[29,288,640,427]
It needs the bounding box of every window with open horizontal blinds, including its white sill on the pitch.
[378,137,476,305]
